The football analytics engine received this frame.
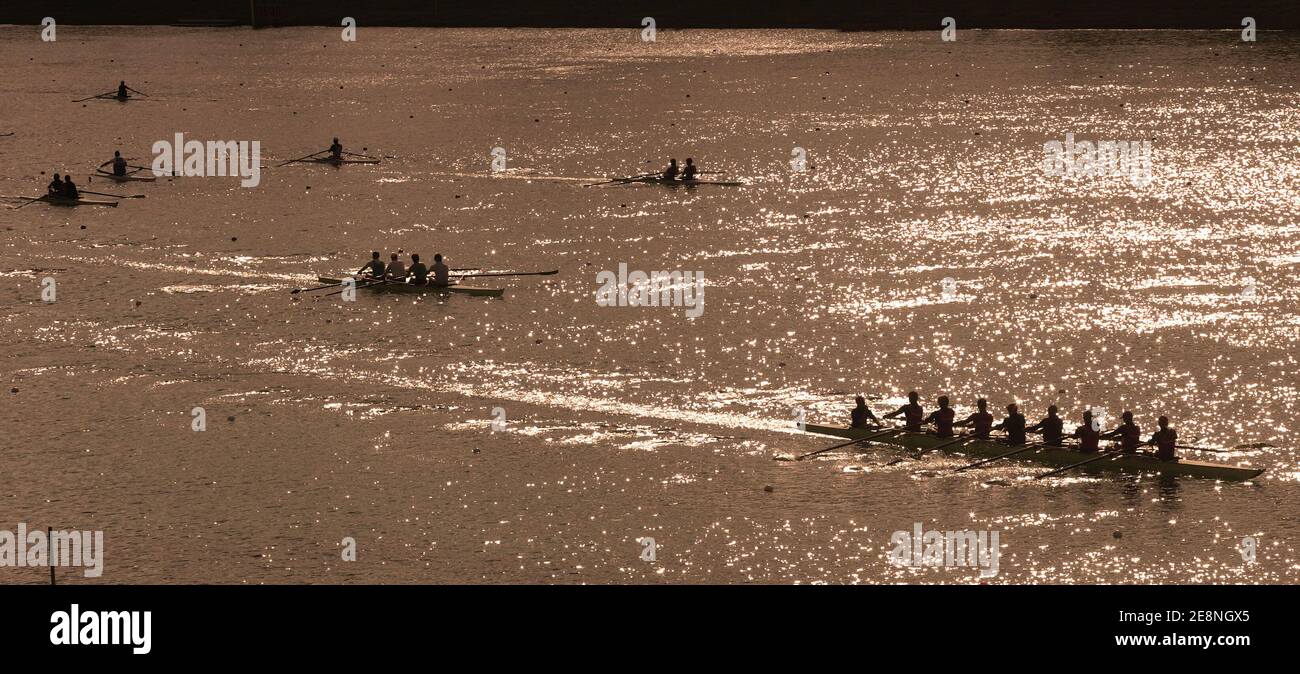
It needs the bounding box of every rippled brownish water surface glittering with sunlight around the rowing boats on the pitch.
[0,26,1300,583]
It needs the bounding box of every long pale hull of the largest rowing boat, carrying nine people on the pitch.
[805,424,1264,481]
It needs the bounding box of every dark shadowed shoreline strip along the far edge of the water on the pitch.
[0,0,1300,31]
